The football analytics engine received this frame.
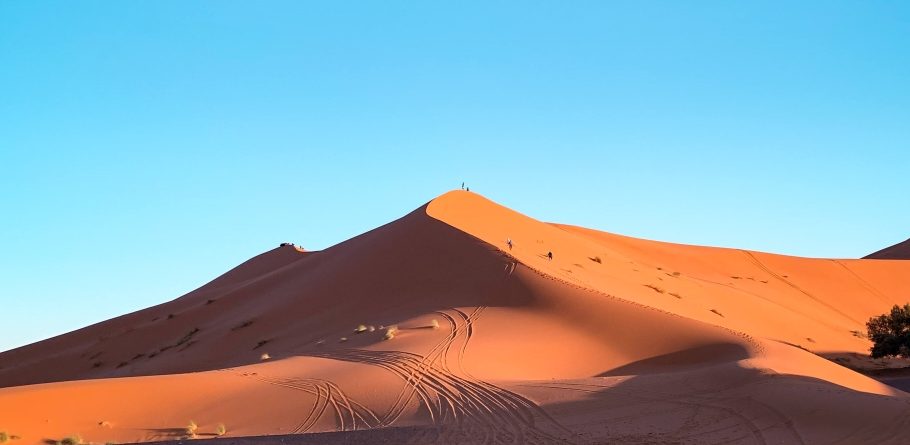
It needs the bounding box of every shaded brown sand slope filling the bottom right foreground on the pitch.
[536,360,910,445]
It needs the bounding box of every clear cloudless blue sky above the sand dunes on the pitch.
[0,0,910,350]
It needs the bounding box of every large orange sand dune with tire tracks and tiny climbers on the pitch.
[0,192,910,444]
